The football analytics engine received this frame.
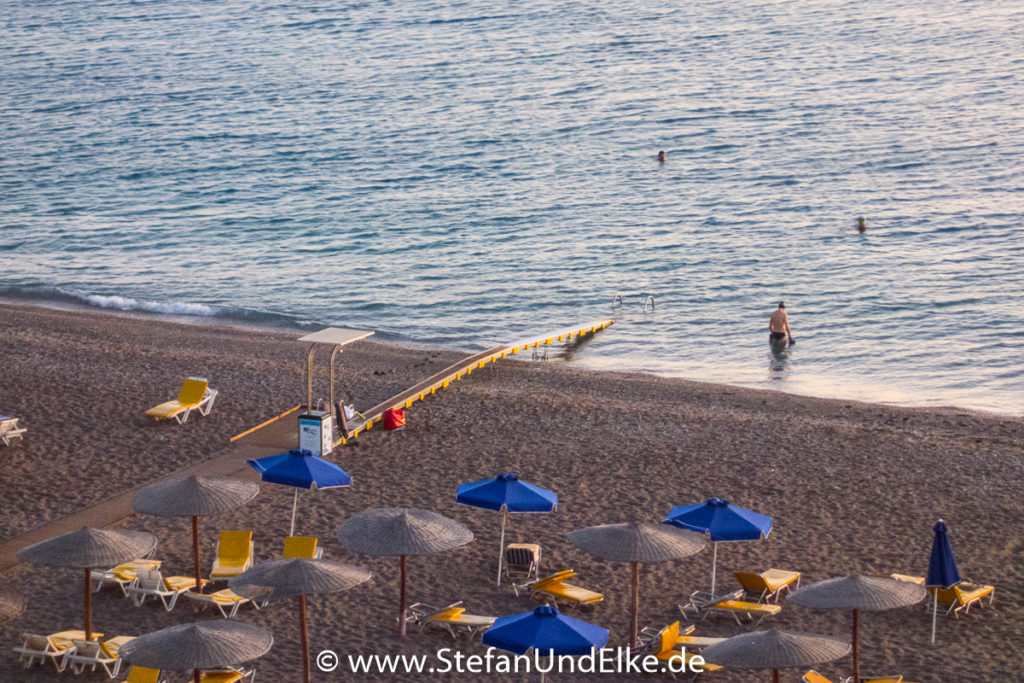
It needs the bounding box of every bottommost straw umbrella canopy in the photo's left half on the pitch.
[118,620,273,683]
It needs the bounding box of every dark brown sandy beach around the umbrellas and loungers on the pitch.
[0,304,1024,683]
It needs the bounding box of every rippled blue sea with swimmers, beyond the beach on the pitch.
[0,0,1024,415]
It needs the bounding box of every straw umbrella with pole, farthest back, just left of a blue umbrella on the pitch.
[131,474,259,593]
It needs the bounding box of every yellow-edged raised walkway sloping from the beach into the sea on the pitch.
[334,319,615,445]
